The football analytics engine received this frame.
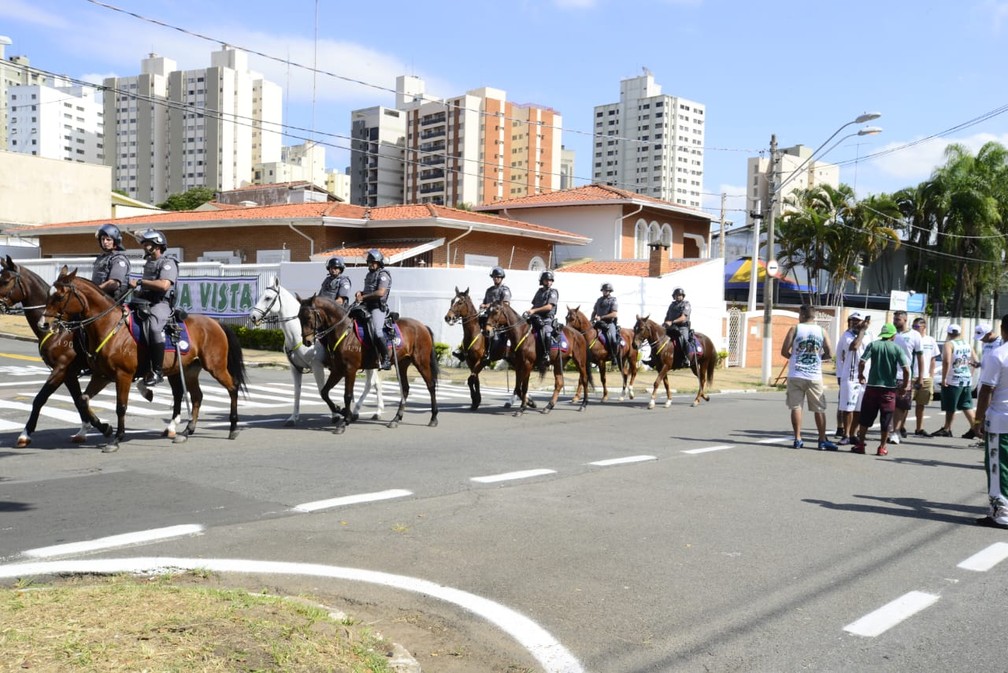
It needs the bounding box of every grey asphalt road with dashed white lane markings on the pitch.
[0,340,1008,672]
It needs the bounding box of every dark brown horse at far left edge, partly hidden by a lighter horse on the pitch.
[0,255,112,448]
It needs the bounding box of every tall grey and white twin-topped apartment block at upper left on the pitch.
[104,46,282,203]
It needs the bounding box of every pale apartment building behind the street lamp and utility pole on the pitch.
[746,145,840,227]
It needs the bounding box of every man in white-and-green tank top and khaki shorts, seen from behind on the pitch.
[780,304,837,451]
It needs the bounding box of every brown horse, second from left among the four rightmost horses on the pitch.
[485,303,594,416]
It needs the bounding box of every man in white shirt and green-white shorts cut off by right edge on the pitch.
[973,315,1008,529]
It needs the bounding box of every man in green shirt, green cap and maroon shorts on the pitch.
[851,322,910,455]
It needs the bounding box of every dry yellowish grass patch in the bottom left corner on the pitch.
[0,573,391,673]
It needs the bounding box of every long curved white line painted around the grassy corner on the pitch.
[0,557,585,673]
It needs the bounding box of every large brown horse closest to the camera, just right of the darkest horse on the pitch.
[39,266,247,452]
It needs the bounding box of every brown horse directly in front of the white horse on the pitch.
[294,294,438,433]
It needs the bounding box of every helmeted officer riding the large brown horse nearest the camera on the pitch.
[129,229,178,386]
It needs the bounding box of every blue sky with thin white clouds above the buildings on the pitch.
[0,0,1008,223]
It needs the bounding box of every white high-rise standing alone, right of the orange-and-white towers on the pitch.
[592,71,706,209]
